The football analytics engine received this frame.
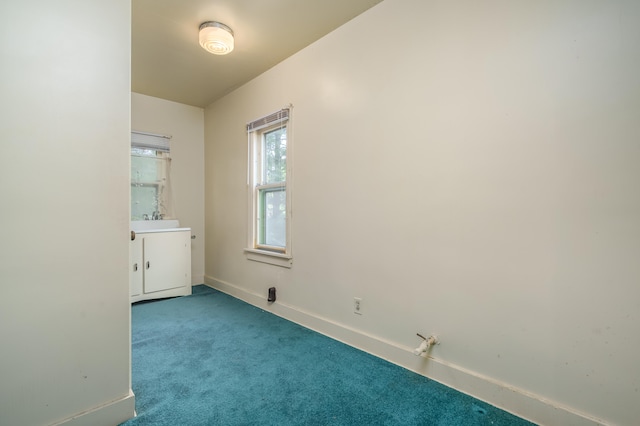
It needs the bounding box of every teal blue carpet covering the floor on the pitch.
[123,286,531,426]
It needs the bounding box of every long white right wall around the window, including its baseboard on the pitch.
[205,0,640,425]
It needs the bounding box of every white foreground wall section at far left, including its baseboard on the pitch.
[0,0,134,426]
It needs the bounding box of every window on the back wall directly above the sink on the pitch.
[131,132,172,220]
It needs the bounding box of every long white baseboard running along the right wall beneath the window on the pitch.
[204,276,606,426]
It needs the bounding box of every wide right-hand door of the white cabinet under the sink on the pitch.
[143,231,191,293]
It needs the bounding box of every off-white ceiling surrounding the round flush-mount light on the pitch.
[131,0,382,107]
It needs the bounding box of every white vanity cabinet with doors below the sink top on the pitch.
[129,228,191,302]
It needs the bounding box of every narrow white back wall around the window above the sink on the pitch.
[131,93,204,284]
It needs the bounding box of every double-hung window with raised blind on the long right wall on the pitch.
[247,109,291,267]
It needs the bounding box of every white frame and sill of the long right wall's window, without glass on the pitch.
[245,107,293,268]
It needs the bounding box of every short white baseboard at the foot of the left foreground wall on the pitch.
[52,389,136,426]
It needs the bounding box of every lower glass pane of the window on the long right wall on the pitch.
[258,188,287,247]
